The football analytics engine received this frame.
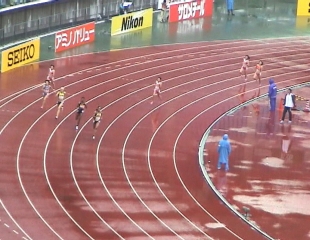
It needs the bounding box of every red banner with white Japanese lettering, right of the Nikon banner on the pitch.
[169,0,213,22]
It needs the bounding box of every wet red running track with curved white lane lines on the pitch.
[0,38,310,240]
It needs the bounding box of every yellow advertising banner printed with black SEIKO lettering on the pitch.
[1,38,40,72]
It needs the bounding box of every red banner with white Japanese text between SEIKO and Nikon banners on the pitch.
[55,22,95,53]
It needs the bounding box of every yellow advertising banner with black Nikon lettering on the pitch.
[111,8,153,36]
